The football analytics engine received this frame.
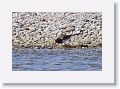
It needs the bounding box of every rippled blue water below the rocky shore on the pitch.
[12,48,102,71]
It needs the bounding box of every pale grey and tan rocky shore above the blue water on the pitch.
[12,12,102,48]
